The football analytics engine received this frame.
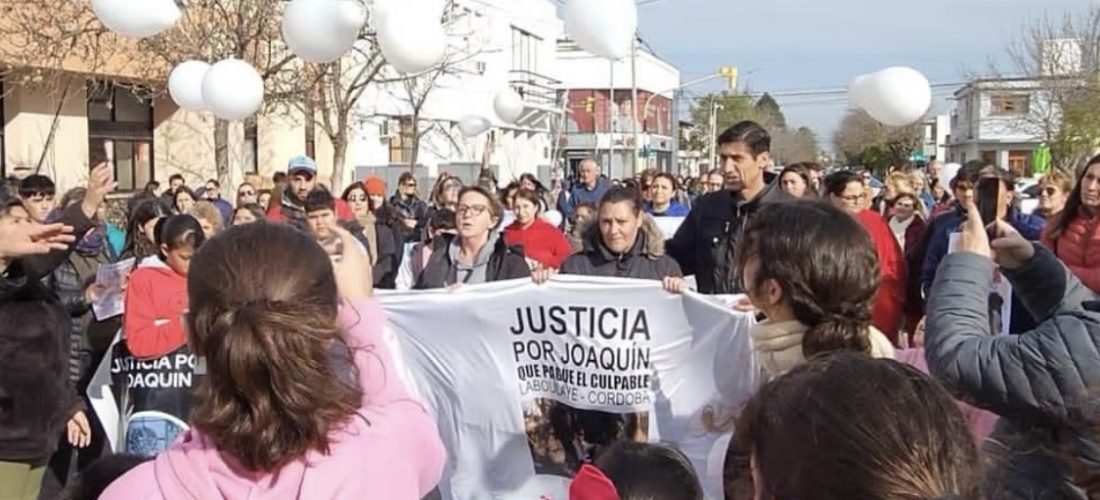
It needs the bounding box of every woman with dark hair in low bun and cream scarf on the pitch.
[737,201,894,378]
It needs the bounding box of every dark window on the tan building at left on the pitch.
[88,81,154,190]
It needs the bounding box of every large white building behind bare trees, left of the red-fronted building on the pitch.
[348,0,563,191]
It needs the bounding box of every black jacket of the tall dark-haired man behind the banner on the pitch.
[666,181,790,295]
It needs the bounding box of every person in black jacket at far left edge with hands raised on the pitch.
[0,164,113,498]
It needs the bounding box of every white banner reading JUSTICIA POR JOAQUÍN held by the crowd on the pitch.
[381,276,758,500]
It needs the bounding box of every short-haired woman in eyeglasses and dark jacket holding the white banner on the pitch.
[414,186,531,290]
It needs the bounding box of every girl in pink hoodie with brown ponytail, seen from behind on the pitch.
[101,224,444,500]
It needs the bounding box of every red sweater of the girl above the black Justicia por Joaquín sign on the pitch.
[122,262,187,359]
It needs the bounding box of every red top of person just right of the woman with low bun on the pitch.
[856,210,906,346]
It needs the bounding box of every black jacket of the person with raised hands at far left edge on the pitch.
[0,203,92,463]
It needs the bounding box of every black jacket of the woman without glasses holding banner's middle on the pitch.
[561,214,683,280]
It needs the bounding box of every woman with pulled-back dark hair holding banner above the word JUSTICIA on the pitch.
[558,187,683,292]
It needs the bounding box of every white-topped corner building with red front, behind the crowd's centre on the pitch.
[558,41,680,178]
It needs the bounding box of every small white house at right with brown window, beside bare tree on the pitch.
[947,78,1054,173]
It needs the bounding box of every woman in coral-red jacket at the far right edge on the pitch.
[1043,156,1100,293]
